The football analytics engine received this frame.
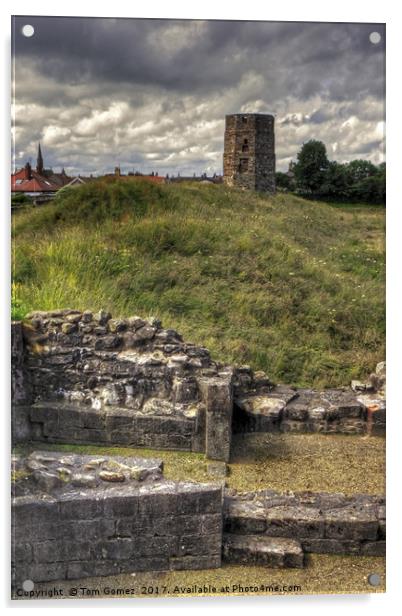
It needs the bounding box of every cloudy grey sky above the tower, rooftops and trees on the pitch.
[13,17,385,175]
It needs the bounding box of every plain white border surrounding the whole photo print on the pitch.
[0,0,402,616]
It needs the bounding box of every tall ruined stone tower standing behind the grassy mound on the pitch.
[223,113,275,193]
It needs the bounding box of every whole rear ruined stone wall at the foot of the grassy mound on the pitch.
[12,310,385,461]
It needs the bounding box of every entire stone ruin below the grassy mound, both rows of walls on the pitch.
[12,310,385,584]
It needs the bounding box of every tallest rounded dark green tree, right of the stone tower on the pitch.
[293,139,329,193]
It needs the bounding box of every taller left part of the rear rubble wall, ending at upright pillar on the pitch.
[14,310,232,460]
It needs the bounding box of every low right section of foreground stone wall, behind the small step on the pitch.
[224,490,386,562]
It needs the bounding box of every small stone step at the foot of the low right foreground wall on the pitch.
[223,534,304,568]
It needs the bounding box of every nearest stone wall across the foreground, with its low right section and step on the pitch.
[12,452,386,587]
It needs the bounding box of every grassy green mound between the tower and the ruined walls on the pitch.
[13,180,385,387]
